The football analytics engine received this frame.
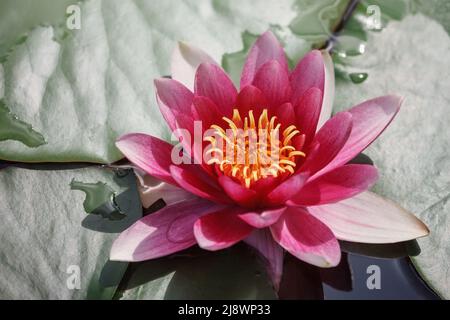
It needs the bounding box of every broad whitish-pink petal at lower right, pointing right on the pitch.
[308,191,429,243]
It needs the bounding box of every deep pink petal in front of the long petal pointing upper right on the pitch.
[301,112,352,175]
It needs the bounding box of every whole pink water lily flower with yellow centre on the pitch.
[111,32,428,287]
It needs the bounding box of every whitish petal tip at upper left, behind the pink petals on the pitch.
[171,42,216,91]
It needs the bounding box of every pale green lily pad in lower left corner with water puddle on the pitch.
[0,167,142,299]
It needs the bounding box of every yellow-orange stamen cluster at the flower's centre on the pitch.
[204,109,305,188]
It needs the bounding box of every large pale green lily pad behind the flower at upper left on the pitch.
[0,0,347,163]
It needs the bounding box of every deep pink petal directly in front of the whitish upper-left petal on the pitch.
[195,63,237,116]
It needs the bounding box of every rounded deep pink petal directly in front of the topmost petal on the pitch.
[253,60,291,108]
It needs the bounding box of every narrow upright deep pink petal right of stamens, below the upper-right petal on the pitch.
[295,87,322,145]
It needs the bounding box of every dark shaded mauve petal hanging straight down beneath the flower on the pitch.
[244,229,284,291]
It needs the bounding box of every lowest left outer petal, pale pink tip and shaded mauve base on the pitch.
[110,198,219,261]
